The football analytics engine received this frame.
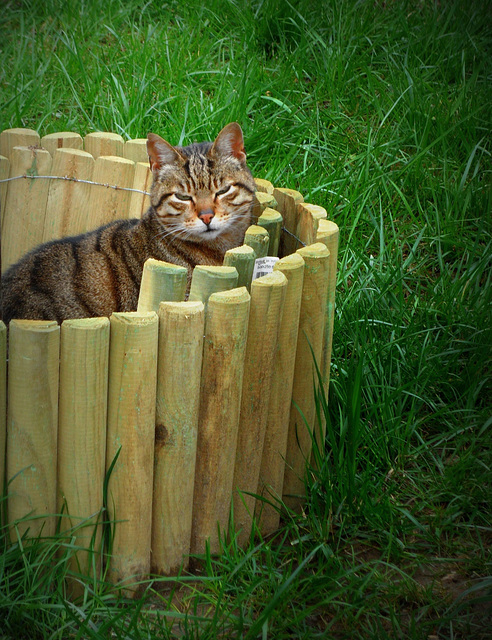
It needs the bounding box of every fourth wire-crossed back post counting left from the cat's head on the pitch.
[2,147,51,270]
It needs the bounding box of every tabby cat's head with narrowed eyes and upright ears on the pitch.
[147,122,255,244]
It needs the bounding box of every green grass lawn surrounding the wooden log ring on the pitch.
[0,0,492,640]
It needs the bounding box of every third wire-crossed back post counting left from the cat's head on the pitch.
[43,148,94,242]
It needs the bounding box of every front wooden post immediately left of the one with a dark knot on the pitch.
[106,312,158,591]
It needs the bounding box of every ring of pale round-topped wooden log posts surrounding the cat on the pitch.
[0,129,339,593]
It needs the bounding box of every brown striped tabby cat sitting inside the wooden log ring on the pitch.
[1,122,255,324]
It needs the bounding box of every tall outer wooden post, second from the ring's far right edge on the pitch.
[283,243,330,510]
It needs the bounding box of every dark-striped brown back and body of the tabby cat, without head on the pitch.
[2,220,143,323]
